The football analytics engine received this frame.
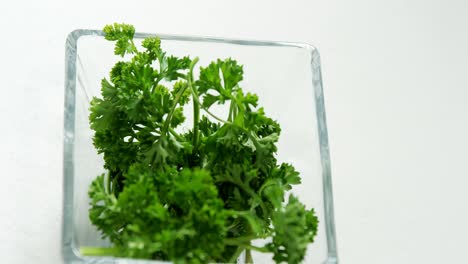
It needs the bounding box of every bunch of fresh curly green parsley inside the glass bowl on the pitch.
[82,24,318,263]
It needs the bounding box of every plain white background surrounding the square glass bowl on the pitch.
[0,0,468,264]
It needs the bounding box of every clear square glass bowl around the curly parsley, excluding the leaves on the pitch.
[63,30,338,264]
